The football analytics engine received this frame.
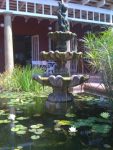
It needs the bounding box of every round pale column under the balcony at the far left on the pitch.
[4,14,14,71]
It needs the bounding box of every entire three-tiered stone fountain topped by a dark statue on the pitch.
[33,3,87,114]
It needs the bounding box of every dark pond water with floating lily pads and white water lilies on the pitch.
[0,94,113,150]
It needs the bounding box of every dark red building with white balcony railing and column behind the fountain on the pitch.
[0,0,113,72]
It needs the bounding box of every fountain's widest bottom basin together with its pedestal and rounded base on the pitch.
[33,75,88,114]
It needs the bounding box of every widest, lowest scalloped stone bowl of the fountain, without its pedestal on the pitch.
[33,74,88,88]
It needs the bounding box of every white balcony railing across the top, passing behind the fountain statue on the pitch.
[0,0,113,25]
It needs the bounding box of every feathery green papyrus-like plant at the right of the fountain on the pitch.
[85,28,113,94]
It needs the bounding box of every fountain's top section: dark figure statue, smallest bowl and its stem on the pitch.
[48,2,76,52]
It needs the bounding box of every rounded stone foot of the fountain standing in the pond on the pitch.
[46,90,74,115]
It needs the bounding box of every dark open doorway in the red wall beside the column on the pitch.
[13,35,31,66]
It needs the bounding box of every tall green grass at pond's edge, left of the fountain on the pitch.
[0,66,44,92]
